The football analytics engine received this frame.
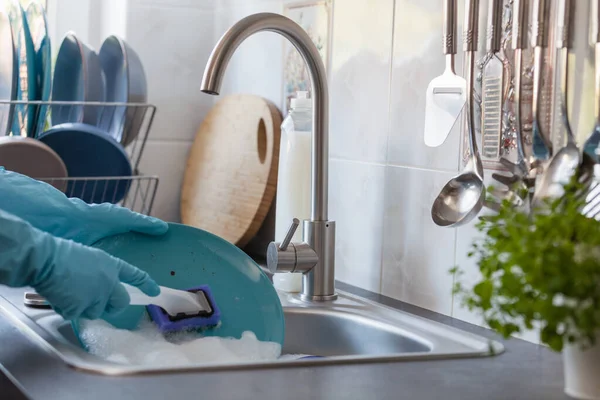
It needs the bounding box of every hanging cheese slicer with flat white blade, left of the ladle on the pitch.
[424,0,467,147]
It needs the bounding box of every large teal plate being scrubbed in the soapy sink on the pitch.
[72,223,285,345]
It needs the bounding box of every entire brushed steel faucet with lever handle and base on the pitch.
[201,13,337,301]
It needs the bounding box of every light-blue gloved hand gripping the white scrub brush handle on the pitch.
[0,211,160,319]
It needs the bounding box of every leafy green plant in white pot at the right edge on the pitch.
[451,184,600,399]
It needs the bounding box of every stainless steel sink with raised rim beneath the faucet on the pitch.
[0,287,504,375]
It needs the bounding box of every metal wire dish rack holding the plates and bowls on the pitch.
[0,100,159,215]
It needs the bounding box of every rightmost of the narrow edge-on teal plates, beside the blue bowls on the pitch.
[26,2,52,137]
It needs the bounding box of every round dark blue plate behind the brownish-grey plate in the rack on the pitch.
[38,123,132,203]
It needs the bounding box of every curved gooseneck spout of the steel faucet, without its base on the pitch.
[201,13,329,221]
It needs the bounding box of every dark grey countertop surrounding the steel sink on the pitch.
[0,283,568,400]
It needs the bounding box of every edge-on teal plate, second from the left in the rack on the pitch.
[5,0,37,136]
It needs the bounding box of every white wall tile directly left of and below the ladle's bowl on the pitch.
[382,166,456,315]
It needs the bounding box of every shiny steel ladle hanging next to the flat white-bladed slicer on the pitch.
[431,0,485,227]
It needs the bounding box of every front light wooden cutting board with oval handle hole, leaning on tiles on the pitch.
[181,95,282,247]
